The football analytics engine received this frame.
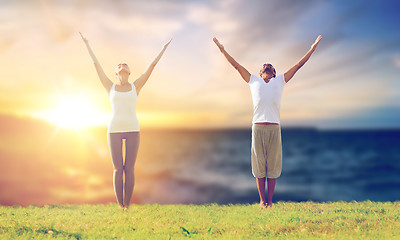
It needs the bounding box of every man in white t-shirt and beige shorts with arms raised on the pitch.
[213,35,322,208]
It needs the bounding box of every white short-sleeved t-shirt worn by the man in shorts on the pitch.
[249,74,286,124]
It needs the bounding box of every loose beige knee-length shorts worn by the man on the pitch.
[251,124,282,178]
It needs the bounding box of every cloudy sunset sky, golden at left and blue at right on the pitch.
[0,0,400,128]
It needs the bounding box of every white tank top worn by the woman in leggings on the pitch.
[107,83,140,133]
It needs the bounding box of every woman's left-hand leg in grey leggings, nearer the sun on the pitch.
[107,133,124,206]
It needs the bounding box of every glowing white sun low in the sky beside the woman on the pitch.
[39,94,108,130]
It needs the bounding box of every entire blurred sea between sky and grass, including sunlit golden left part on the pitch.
[0,115,400,206]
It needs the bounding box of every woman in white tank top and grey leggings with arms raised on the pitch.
[79,33,172,210]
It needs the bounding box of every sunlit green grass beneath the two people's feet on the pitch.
[0,201,400,240]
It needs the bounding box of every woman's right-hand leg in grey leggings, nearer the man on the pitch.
[124,132,140,207]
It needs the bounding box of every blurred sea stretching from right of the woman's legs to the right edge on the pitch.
[135,128,400,204]
